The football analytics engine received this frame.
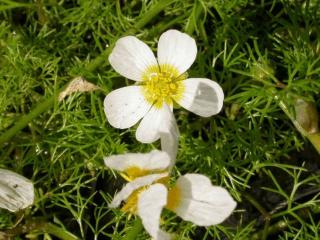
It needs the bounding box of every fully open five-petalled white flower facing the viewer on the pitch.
[104,30,224,143]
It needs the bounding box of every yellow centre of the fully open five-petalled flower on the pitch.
[142,64,187,108]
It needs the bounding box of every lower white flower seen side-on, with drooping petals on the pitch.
[105,151,236,240]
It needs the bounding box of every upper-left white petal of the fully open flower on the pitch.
[109,36,158,81]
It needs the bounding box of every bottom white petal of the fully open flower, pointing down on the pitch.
[136,104,170,143]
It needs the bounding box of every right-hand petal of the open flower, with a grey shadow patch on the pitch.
[177,78,224,117]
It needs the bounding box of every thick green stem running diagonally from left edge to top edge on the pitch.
[0,0,175,147]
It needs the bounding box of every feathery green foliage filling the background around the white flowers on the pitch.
[0,0,320,240]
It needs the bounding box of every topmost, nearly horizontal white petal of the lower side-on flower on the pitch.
[104,150,170,171]
